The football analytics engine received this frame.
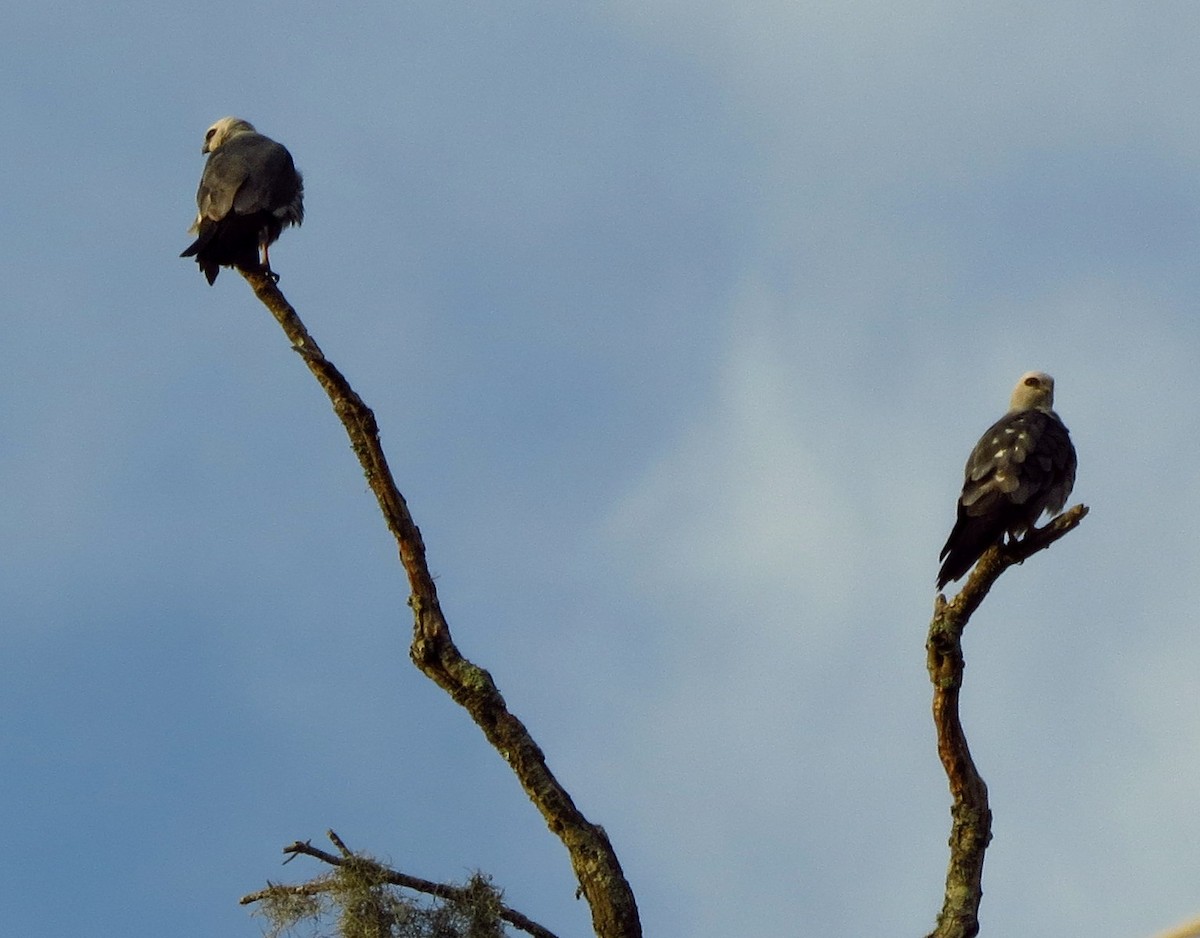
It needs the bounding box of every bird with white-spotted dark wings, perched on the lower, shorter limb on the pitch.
[937,372,1076,590]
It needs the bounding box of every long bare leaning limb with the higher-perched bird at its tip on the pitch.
[241,271,642,938]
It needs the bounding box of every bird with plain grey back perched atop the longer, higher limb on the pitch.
[180,118,304,284]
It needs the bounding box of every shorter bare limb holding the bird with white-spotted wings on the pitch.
[925,505,1087,938]
